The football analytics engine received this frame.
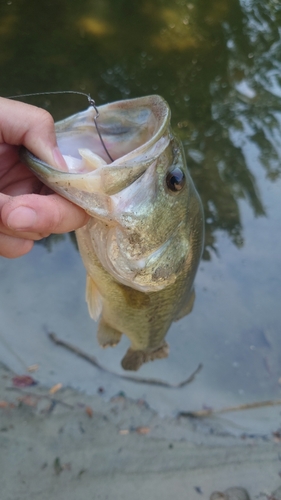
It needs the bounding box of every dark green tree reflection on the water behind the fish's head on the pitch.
[0,0,281,258]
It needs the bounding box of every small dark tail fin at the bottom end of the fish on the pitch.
[121,342,169,371]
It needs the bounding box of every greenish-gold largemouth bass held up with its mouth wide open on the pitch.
[21,95,204,370]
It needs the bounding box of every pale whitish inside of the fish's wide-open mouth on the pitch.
[56,96,170,170]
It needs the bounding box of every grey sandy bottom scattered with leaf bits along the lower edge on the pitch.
[0,365,281,500]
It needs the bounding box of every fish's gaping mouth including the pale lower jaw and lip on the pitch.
[21,95,170,203]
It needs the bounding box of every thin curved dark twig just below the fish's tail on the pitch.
[48,332,203,389]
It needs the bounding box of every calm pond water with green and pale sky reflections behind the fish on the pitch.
[0,0,281,433]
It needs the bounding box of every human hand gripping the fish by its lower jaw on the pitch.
[0,97,89,258]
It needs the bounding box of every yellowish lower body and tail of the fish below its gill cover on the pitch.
[76,226,187,370]
